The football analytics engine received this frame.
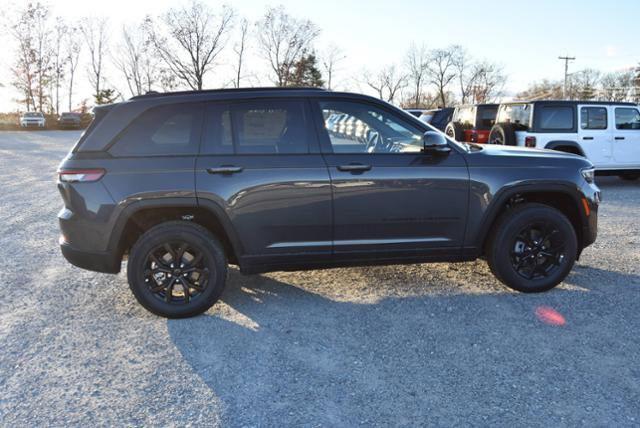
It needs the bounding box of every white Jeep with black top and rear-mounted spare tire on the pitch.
[489,101,640,180]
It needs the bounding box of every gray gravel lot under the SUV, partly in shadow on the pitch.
[0,131,640,427]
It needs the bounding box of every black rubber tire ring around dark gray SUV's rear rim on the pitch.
[127,225,227,318]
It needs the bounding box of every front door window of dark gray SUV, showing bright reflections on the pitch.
[320,101,423,153]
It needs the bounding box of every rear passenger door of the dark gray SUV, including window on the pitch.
[196,99,331,264]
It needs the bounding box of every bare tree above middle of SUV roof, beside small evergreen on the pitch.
[256,6,320,86]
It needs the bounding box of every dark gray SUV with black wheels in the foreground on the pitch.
[58,88,600,318]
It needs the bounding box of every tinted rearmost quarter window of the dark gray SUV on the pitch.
[110,104,201,156]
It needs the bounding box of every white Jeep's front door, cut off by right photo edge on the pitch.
[613,106,640,168]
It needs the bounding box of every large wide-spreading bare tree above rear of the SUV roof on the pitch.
[145,0,234,90]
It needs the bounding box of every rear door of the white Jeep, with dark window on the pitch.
[578,105,613,168]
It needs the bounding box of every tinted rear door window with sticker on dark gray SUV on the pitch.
[205,100,309,154]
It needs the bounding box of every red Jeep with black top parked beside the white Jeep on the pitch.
[444,104,498,144]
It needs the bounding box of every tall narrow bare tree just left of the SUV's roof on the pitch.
[80,18,109,99]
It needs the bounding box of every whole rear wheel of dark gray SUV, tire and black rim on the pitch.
[127,221,227,318]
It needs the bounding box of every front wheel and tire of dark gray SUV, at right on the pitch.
[486,203,578,293]
